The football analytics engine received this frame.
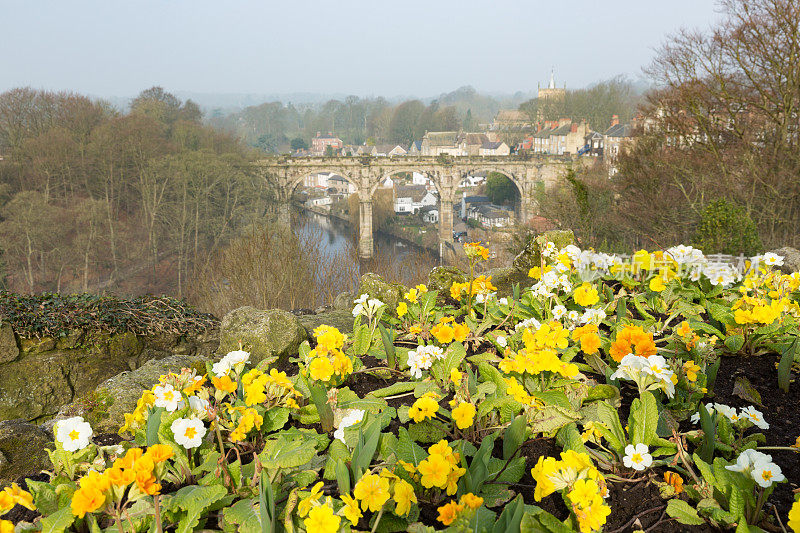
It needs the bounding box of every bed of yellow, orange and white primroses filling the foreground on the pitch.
[0,241,800,533]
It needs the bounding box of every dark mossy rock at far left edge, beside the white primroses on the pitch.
[0,420,53,487]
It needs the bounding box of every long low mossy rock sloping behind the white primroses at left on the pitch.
[61,355,206,434]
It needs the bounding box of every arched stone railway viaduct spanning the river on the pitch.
[254,156,587,262]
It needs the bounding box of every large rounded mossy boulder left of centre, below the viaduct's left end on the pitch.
[219,306,306,365]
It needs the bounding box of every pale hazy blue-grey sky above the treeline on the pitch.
[0,0,718,96]
